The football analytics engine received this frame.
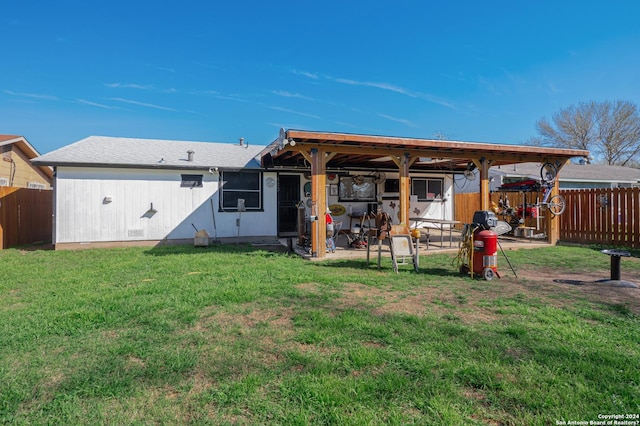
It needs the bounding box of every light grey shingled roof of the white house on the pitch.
[32,136,264,170]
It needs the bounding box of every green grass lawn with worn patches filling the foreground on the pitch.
[0,245,640,425]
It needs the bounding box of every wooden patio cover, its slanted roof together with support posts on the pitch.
[261,129,589,258]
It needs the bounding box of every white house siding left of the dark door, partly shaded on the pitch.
[54,166,277,244]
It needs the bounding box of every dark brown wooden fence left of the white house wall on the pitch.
[0,186,53,250]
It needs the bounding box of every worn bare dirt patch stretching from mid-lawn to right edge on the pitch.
[300,269,640,324]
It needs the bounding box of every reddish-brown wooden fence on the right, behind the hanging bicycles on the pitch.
[454,188,640,248]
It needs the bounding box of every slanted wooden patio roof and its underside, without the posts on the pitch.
[262,130,589,172]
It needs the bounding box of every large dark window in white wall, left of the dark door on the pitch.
[220,172,262,211]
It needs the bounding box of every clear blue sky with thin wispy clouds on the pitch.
[0,0,640,153]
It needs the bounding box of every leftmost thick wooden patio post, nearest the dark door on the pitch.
[309,148,327,258]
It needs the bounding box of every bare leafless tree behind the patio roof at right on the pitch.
[531,101,640,166]
